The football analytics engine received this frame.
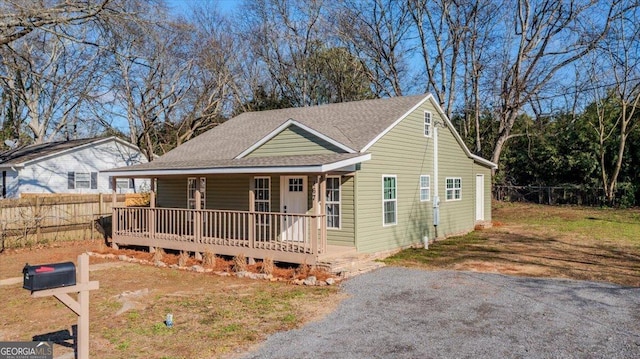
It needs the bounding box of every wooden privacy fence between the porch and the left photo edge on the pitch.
[0,194,128,249]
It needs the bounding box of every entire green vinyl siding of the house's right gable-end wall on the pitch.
[355,101,491,253]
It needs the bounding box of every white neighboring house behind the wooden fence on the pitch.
[0,137,149,198]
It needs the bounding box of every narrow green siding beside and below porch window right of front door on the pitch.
[327,176,355,246]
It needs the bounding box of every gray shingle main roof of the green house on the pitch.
[152,95,427,169]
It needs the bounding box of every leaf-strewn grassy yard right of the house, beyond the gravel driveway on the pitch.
[386,203,640,287]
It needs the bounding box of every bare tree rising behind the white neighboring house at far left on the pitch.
[0,28,102,143]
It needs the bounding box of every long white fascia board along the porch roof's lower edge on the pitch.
[100,153,371,178]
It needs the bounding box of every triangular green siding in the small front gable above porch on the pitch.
[247,125,345,157]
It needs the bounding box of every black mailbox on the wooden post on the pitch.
[22,262,76,292]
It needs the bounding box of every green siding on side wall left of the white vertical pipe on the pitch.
[355,102,437,253]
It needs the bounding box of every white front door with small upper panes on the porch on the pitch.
[280,176,308,242]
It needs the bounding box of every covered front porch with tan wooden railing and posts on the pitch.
[111,156,370,265]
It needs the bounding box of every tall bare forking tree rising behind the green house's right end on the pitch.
[484,0,627,163]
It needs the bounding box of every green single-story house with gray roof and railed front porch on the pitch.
[106,94,497,264]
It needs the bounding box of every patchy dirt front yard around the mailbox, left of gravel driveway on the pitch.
[0,241,342,358]
